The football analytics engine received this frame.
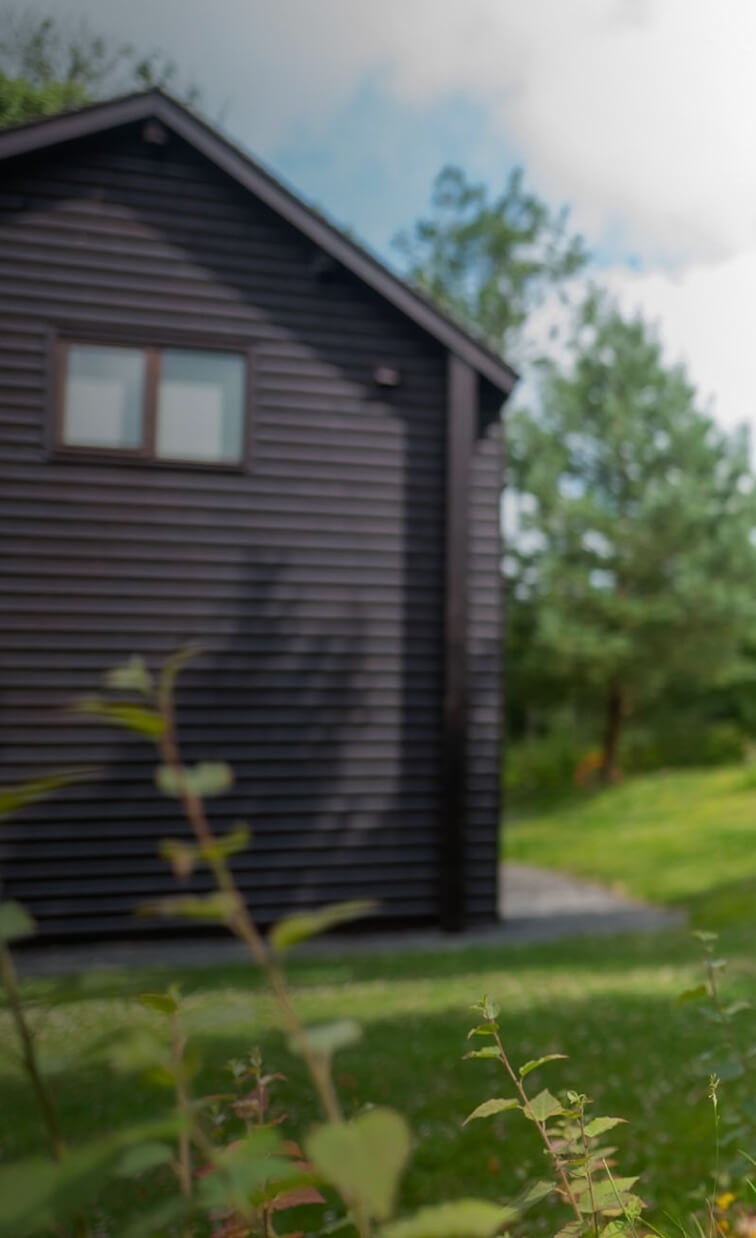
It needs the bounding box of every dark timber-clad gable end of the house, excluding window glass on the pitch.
[0,92,513,936]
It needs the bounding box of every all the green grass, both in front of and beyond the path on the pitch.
[0,768,756,1236]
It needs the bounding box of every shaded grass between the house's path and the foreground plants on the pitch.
[0,929,755,1234]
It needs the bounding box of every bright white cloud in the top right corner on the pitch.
[378,0,756,258]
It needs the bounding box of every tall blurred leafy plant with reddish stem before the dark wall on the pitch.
[60,649,532,1238]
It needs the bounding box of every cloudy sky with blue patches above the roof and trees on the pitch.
[37,0,756,426]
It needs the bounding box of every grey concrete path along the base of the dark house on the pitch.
[16,864,685,976]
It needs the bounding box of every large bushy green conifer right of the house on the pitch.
[506,295,756,780]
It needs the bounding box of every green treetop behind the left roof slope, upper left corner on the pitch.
[0,14,197,128]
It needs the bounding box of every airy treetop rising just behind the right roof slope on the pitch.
[395,167,588,358]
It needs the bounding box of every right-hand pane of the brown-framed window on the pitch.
[157,348,245,464]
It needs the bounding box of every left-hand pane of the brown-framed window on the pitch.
[63,344,145,447]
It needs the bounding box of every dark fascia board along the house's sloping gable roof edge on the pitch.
[0,89,517,399]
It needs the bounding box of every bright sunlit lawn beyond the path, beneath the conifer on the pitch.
[504,765,756,925]
